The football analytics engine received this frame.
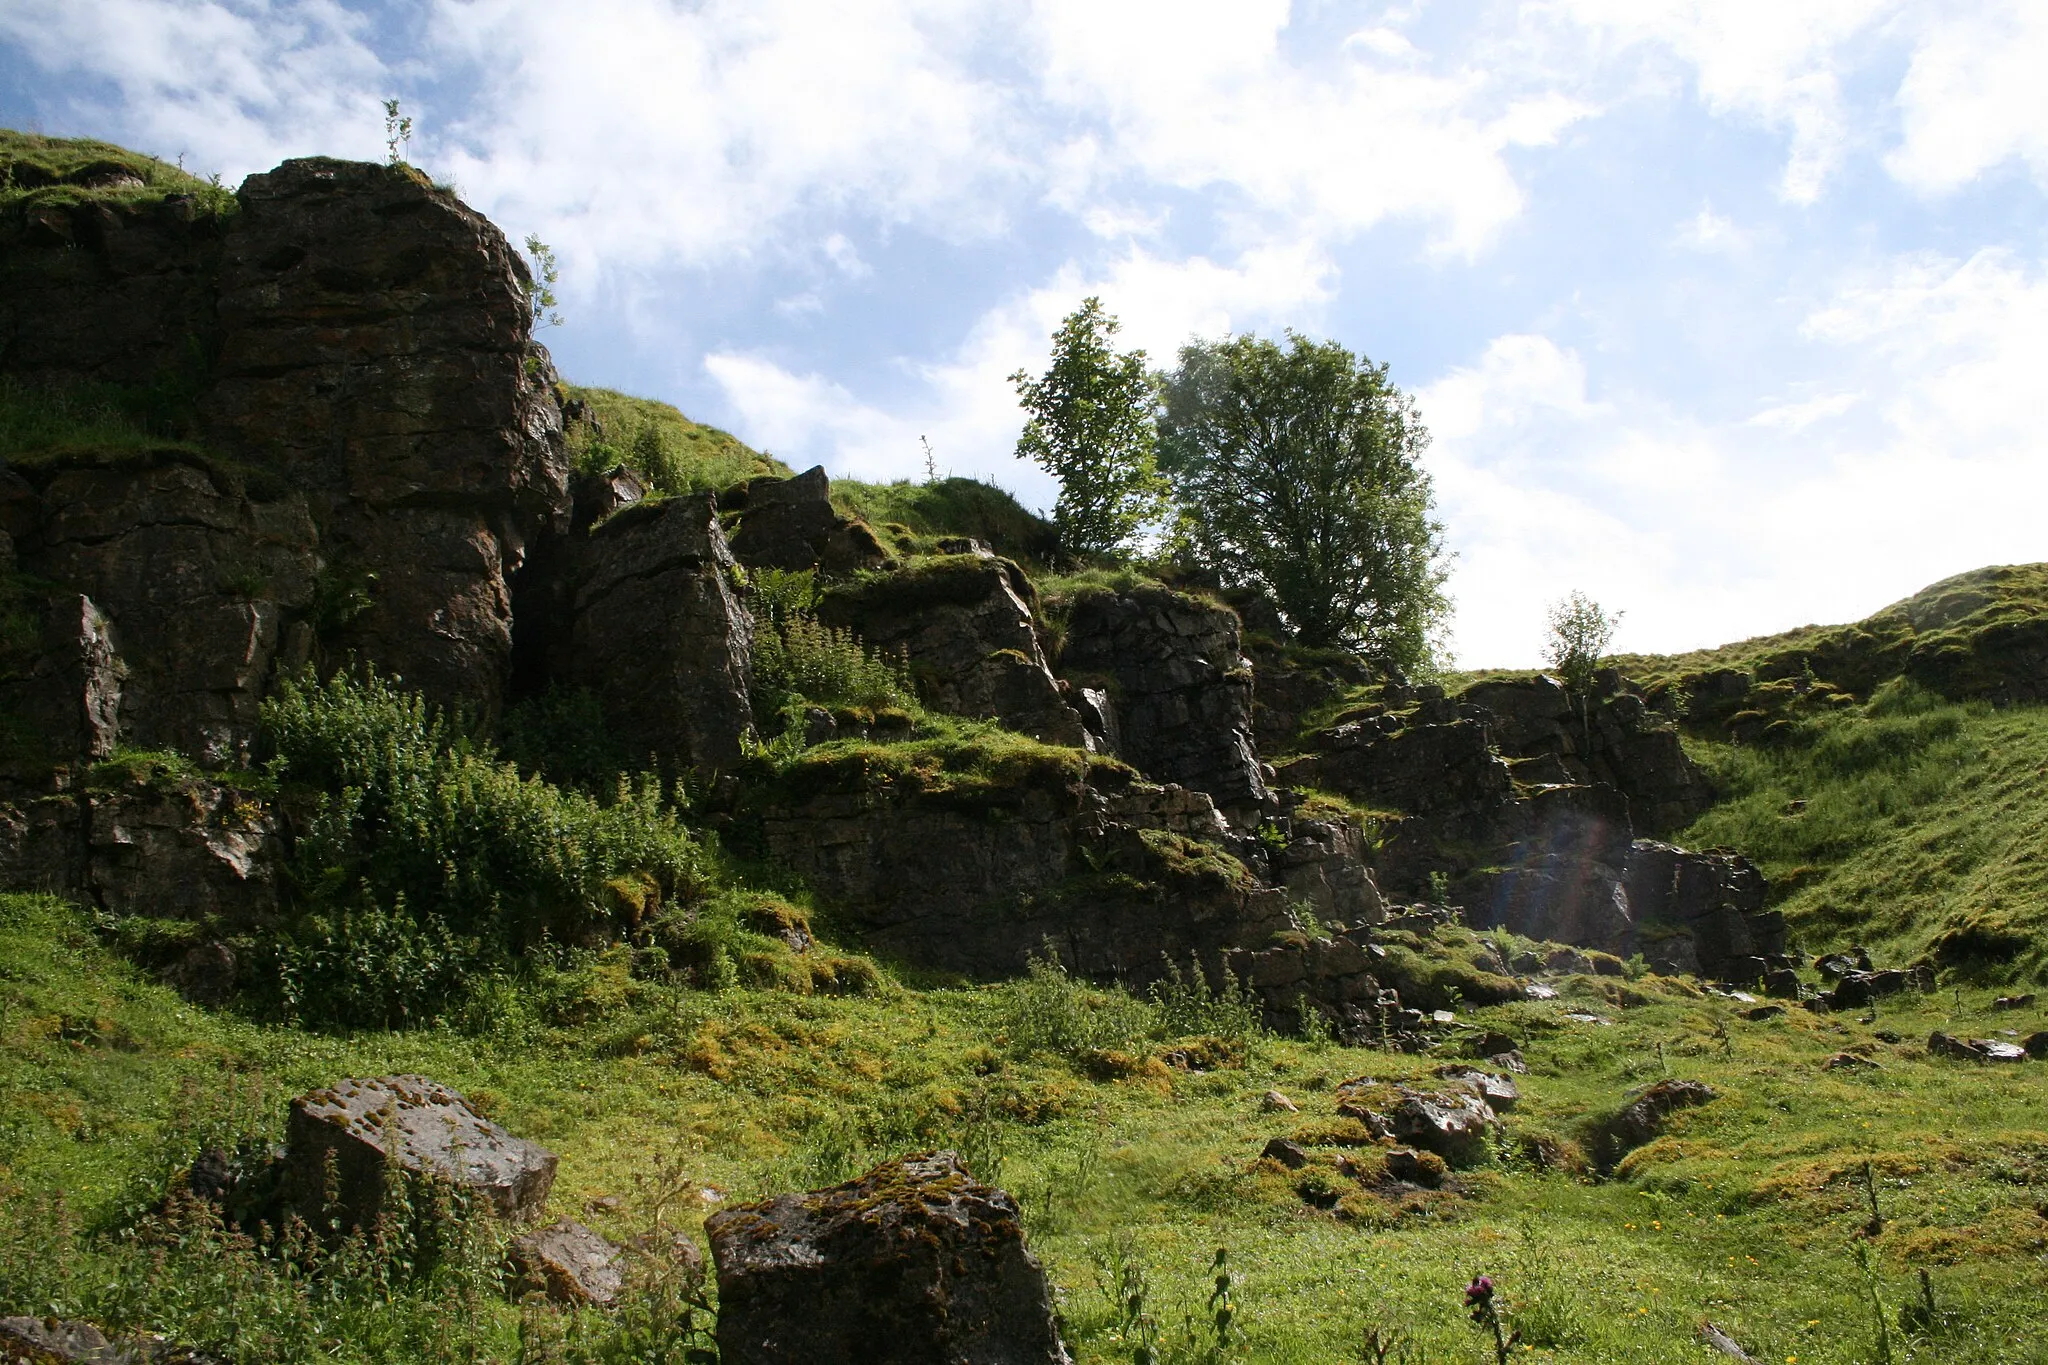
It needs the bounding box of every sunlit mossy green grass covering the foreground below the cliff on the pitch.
[0,896,2048,1365]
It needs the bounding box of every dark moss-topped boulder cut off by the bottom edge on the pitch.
[705,1152,1069,1365]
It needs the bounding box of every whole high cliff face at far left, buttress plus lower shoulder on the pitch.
[0,160,567,761]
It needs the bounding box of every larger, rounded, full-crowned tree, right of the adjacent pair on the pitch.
[1159,332,1450,669]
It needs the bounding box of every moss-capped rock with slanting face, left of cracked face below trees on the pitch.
[823,552,1090,747]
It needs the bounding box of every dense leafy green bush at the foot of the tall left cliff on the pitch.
[262,671,705,1025]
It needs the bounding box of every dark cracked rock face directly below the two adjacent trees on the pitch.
[1059,587,1270,823]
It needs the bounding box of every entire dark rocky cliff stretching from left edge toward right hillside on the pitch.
[0,133,1966,1007]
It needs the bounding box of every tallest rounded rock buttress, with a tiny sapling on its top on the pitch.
[203,158,569,714]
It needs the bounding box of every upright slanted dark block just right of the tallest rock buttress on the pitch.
[557,497,754,772]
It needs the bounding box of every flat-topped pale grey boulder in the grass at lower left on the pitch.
[285,1076,555,1228]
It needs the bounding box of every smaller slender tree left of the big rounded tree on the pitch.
[1010,297,1165,555]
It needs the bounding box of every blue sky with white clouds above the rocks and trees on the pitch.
[0,0,2048,667]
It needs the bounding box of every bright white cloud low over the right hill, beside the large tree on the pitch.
[1417,250,2048,665]
